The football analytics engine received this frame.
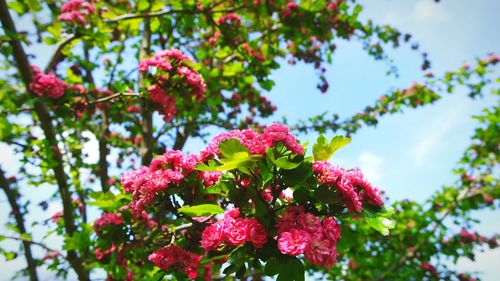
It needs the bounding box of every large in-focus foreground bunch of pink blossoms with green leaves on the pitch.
[94,123,390,279]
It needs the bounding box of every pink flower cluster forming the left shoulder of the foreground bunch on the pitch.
[121,150,198,216]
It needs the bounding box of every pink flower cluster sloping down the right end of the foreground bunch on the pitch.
[312,161,384,213]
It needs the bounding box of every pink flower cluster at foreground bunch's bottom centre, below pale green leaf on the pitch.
[201,208,267,249]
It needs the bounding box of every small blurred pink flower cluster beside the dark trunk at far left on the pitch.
[29,72,68,99]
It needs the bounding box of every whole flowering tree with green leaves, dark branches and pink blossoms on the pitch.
[0,0,500,280]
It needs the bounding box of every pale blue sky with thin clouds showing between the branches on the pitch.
[0,0,500,280]
